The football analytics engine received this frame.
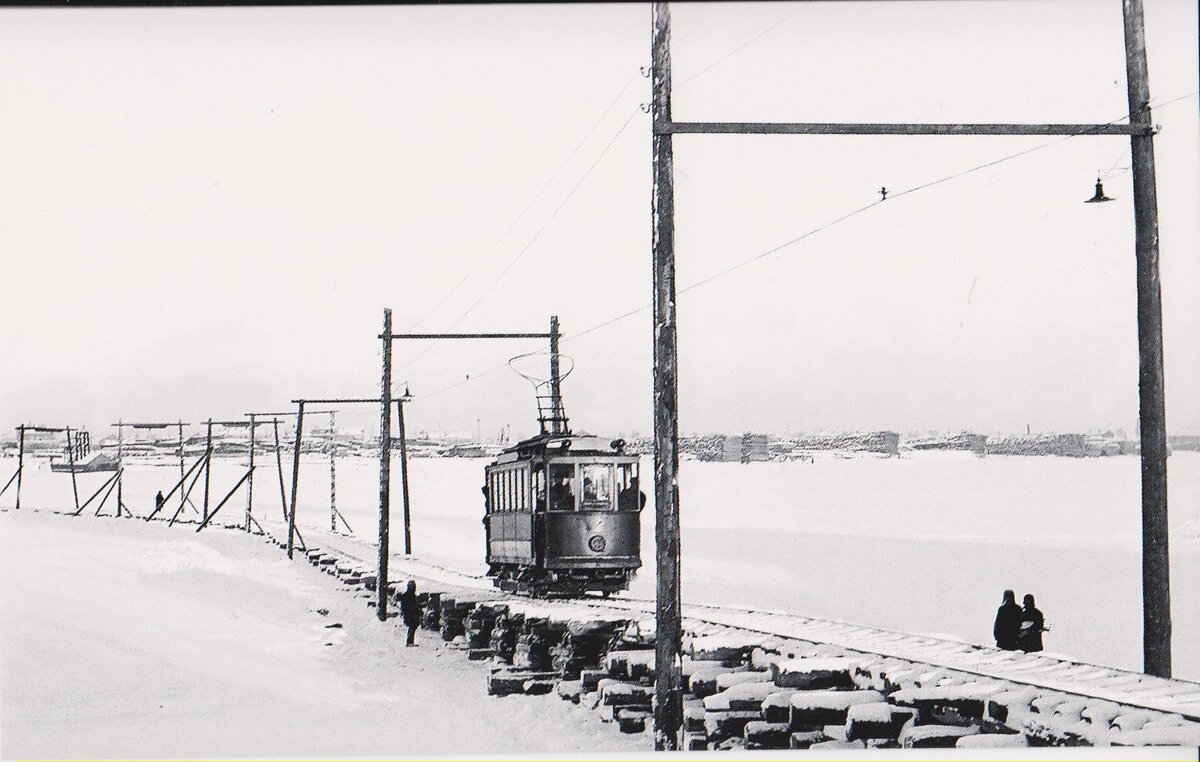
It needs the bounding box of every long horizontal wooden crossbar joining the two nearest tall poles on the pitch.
[654,121,1153,136]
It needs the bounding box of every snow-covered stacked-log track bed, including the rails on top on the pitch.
[283,520,1200,749]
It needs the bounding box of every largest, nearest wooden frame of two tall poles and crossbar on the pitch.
[650,0,1171,734]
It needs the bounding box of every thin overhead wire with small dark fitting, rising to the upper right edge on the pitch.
[405,90,1200,410]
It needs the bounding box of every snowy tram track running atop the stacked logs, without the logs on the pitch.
[283,520,1200,721]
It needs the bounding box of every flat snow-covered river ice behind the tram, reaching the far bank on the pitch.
[0,452,1200,679]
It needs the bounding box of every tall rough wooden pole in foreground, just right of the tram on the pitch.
[652,1,683,751]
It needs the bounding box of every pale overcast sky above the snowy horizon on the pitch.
[0,0,1200,434]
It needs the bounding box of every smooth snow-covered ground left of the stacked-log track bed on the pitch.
[0,506,650,760]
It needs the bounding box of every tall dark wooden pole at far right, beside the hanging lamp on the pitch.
[1122,0,1171,677]
